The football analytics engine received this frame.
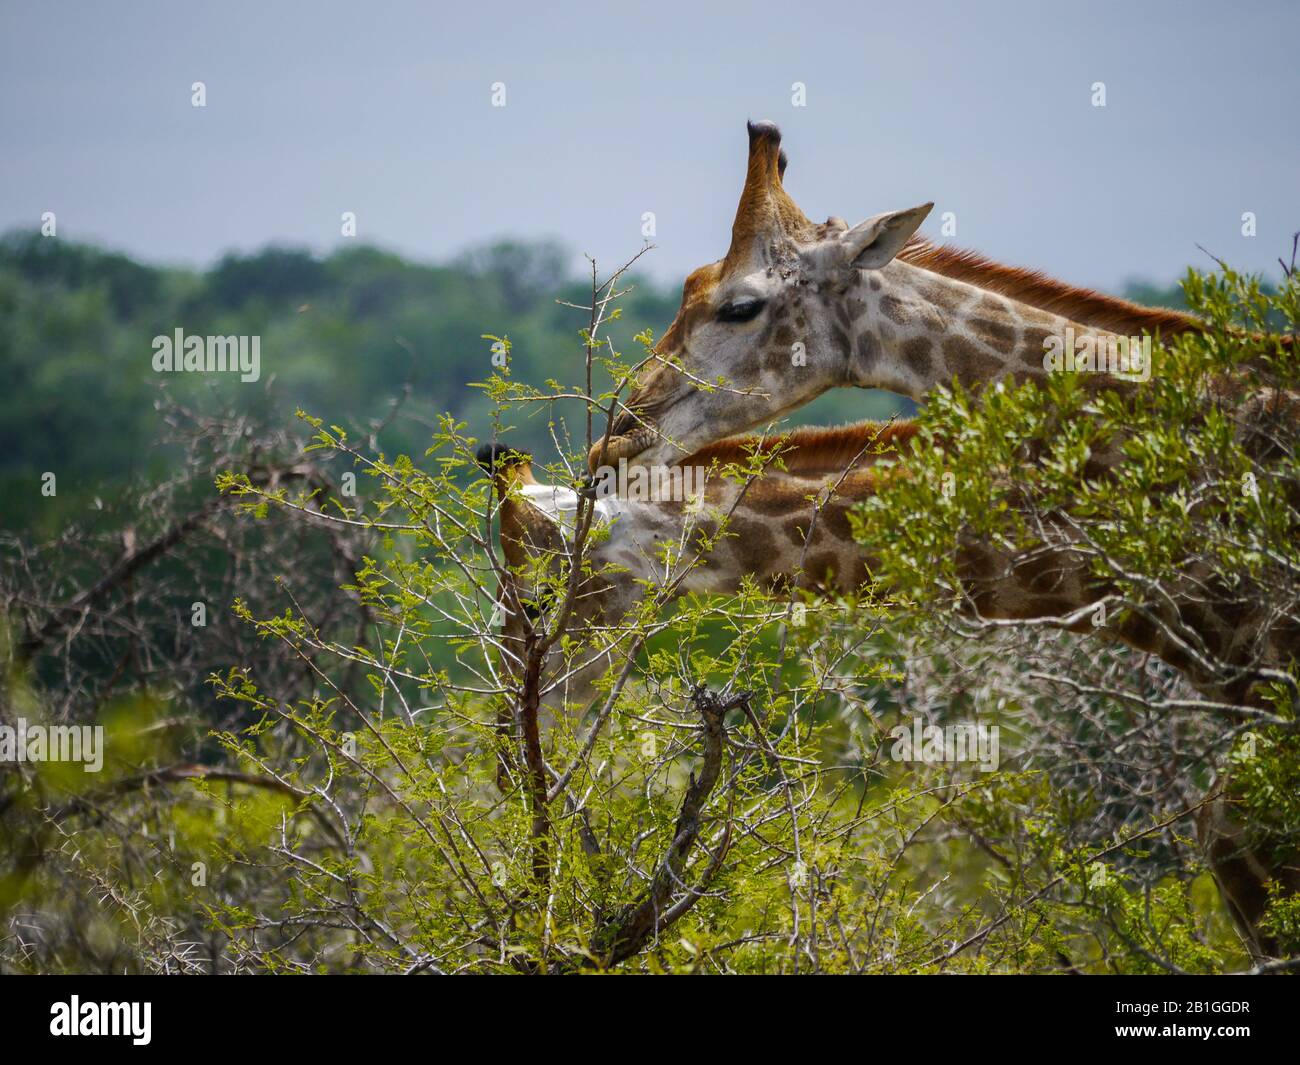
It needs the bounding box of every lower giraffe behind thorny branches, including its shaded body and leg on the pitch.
[491,421,1300,961]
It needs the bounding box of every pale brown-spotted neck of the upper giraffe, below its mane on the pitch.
[845,260,1125,401]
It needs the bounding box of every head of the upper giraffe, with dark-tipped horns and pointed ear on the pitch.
[589,122,932,469]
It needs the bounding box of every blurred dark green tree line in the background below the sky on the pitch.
[0,231,930,532]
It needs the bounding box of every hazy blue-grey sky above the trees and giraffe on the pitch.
[0,0,1300,287]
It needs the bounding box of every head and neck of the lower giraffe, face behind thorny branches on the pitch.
[477,423,915,733]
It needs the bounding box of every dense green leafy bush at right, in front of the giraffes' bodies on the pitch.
[854,260,1300,971]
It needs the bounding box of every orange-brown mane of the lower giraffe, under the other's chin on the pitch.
[680,421,917,473]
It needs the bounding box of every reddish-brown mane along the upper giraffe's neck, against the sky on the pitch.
[898,237,1203,337]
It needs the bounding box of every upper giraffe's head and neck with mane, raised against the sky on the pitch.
[589,122,1216,469]
